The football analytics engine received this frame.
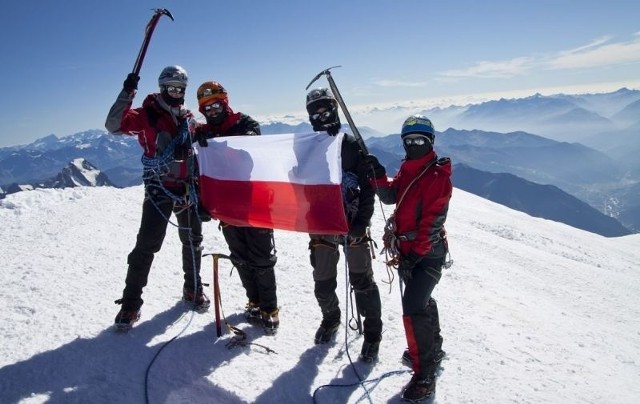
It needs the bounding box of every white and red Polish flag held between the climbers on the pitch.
[195,133,348,234]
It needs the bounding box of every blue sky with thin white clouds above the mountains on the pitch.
[0,0,640,147]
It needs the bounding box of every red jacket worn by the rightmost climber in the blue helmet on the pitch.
[373,151,453,256]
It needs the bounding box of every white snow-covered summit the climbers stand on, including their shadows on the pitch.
[0,186,640,404]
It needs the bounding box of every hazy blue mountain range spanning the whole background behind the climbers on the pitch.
[0,89,640,236]
